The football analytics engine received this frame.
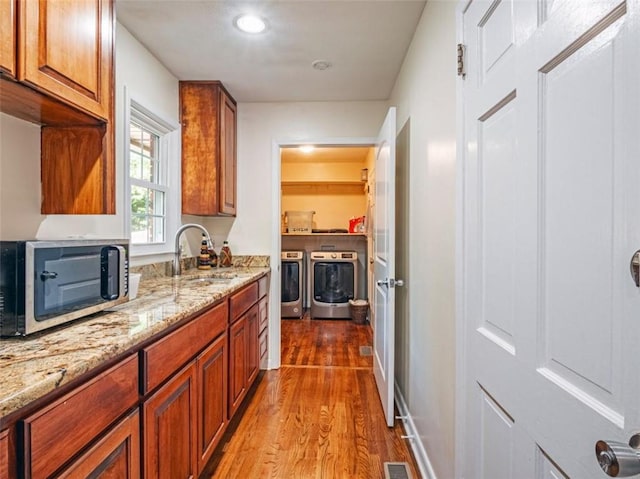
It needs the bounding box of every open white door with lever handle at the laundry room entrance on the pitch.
[373,107,396,427]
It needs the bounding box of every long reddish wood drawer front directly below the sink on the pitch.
[142,302,228,394]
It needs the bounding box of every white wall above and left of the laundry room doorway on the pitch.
[212,99,386,255]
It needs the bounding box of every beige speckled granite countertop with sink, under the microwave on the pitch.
[0,267,269,430]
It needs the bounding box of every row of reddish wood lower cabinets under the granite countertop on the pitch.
[0,282,268,479]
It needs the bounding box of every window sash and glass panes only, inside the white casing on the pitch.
[129,120,168,244]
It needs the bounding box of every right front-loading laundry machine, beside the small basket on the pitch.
[309,251,358,319]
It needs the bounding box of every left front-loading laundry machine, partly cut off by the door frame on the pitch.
[280,251,305,319]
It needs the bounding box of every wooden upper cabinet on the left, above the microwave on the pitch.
[0,0,116,214]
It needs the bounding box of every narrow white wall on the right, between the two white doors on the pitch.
[390,1,456,478]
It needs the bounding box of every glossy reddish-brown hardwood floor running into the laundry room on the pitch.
[202,317,420,479]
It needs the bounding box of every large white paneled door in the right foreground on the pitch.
[456,0,640,479]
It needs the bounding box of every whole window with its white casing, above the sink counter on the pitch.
[125,94,180,255]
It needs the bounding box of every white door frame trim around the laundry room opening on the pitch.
[267,137,376,369]
